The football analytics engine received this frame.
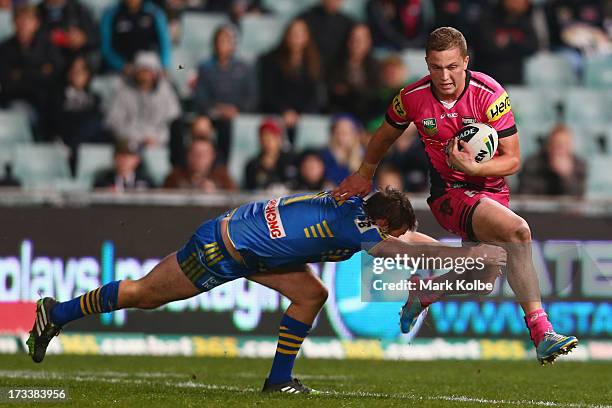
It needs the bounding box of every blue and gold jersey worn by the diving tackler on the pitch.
[228,192,388,269]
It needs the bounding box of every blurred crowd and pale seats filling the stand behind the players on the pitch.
[0,0,612,197]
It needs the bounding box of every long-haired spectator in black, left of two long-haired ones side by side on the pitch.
[259,19,322,144]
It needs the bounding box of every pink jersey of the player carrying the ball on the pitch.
[386,71,516,198]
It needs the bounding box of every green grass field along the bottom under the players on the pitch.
[0,355,612,408]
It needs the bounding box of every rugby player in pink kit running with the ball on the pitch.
[334,27,578,364]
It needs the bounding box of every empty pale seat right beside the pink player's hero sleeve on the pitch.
[506,86,557,128]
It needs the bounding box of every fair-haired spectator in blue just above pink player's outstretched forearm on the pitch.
[321,114,363,184]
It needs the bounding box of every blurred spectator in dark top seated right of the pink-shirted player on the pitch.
[519,125,587,197]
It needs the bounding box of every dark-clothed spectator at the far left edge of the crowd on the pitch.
[0,5,64,140]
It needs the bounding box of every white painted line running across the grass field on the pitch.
[0,370,612,408]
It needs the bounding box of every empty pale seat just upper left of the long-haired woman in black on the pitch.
[238,15,285,61]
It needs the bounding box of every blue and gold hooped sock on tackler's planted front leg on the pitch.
[268,314,311,384]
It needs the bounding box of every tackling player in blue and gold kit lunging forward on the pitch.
[28,189,506,394]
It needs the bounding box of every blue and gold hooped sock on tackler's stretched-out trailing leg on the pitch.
[51,281,121,326]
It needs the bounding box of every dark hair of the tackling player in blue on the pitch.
[364,187,417,231]
